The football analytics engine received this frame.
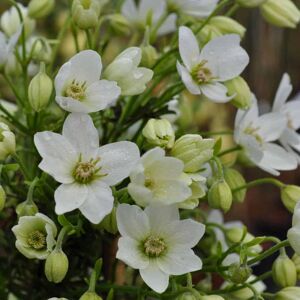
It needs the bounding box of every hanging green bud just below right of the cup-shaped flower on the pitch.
[45,249,69,283]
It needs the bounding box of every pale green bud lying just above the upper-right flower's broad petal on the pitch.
[209,16,246,38]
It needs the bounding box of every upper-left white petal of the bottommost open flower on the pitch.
[117,204,150,241]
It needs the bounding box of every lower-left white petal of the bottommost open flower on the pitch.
[116,237,149,269]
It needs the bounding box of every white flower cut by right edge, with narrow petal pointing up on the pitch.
[273,74,300,164]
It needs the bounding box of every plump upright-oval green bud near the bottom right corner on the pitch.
[272,253,297,288]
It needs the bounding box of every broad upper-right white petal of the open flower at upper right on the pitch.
[200,34,249,81]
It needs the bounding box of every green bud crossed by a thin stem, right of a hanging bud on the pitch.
[224,168,247,203]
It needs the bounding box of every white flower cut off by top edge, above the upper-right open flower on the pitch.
[167,0,219,18]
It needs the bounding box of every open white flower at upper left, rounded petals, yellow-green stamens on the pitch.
[55,50,121,113]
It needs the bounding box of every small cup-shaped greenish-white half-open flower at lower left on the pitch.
[12,213,57,259]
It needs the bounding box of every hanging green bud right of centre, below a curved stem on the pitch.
[208,179,232,212]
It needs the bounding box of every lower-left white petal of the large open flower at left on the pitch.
[54,183,88,215]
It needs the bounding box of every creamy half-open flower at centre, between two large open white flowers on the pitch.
[128,147,192,206]
